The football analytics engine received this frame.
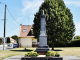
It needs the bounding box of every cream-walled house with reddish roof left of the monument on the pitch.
[19,24,37,47]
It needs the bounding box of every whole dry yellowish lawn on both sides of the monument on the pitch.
[0,47,80,60]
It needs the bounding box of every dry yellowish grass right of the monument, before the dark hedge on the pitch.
[55,47,80,57]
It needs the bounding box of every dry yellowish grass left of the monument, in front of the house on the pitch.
[0,48,36,60]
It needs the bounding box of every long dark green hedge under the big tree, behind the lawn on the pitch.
[48,39,80,47]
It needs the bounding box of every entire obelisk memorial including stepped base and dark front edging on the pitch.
[21,10,63,60]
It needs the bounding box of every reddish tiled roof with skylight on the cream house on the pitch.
[19,25,32,37]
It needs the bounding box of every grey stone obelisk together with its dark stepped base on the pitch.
[36,10,49,54]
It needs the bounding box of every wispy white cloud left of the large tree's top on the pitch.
[16,0,43,22]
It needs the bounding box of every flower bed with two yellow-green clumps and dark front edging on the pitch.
[21,51,63,60]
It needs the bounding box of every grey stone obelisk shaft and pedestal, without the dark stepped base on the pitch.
[39,10,47,46]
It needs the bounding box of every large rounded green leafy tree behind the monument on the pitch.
[33,0,75,50]
